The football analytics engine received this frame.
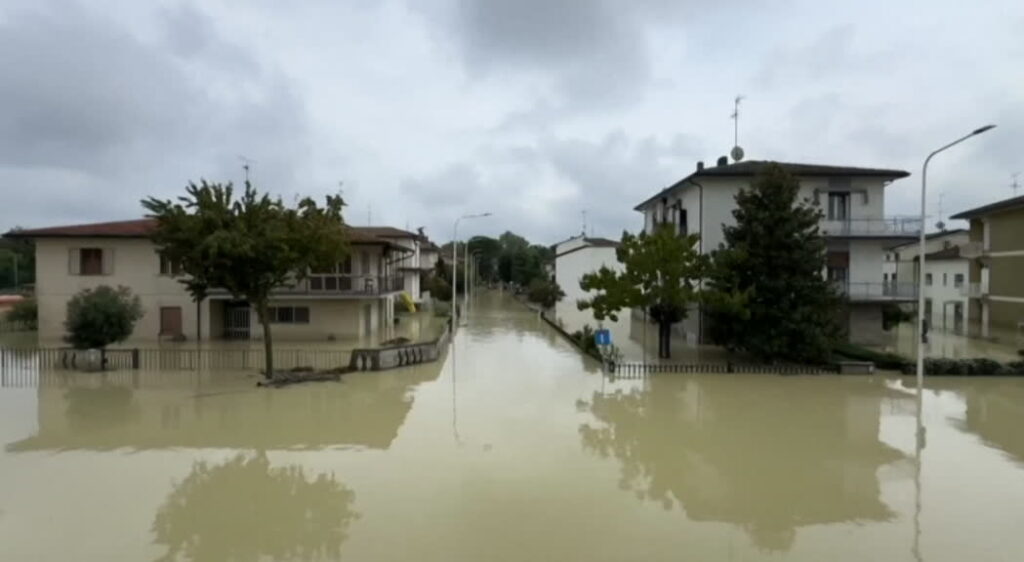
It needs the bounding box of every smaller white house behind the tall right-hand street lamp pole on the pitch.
[882,229,971,333]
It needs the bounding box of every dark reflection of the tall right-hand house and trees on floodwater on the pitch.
[580,376,901,551]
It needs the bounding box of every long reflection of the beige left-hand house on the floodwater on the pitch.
[7,363,440,451]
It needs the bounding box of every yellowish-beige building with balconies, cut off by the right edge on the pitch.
[951,197,1024,340]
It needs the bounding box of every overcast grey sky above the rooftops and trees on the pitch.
[0,0,1024,244]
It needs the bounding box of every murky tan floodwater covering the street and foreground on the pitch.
[0,294,1024,562]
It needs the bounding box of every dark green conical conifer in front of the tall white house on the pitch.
[708,164,842,361]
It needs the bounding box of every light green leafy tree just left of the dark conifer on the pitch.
[577,224,705,358]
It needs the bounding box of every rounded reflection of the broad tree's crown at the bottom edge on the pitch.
[153,452,358,562]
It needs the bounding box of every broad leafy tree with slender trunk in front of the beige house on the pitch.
[142,180,348,378]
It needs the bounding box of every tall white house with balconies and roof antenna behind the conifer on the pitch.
[635,158,921,344]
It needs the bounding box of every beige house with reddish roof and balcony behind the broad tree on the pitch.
[7,219,409,344]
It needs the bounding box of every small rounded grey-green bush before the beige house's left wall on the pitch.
[65,285,142,349]
